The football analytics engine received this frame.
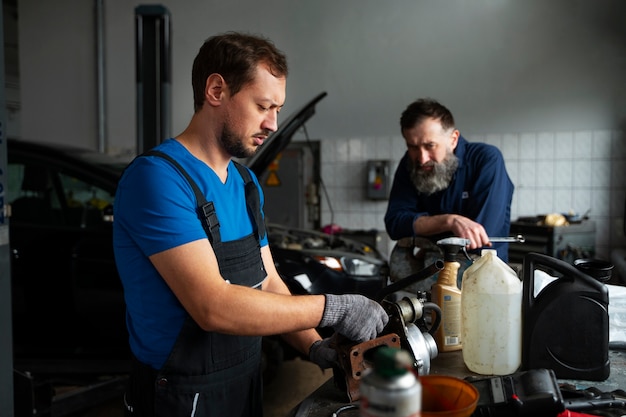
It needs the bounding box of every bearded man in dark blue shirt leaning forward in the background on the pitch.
[385,99,514,290]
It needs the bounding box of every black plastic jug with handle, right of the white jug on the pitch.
[522,253,611,381]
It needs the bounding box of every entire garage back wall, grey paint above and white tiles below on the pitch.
[8,0,626,258]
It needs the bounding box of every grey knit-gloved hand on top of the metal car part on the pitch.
[320,294,389,343]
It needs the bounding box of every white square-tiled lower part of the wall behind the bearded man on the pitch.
[321,130,626,260]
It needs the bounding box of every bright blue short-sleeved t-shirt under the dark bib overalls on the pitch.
[113,139,268,369]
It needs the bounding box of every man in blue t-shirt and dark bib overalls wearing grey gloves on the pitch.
[114,33,388,417]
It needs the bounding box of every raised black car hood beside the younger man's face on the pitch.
[241,91,327,177]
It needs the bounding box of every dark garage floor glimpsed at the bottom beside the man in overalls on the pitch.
[81,359,333,417]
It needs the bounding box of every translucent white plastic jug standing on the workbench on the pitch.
[461,249,522,375]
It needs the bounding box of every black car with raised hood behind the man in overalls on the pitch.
[5,93,388,408]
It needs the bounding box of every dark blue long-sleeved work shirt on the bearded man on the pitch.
[385,136,515,262]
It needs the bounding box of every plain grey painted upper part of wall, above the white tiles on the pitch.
[18,0,626,152]
